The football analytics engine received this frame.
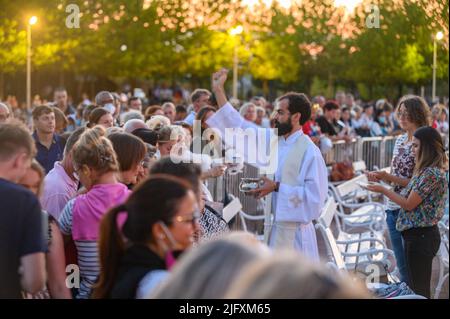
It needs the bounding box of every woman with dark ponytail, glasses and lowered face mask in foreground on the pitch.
[93,174,199,299]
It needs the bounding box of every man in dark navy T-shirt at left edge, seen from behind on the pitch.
[0,121,48,299]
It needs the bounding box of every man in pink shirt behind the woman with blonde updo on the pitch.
[41,127,85,220]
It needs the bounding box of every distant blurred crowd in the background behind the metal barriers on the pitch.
[0,86,449,149]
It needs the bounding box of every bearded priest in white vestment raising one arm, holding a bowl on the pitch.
[206,70,328,260]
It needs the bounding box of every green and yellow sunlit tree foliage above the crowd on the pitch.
[0,0,448,99]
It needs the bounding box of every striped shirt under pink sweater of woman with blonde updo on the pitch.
[59,199,100,299]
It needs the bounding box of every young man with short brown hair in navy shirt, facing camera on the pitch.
[32,105,64,173]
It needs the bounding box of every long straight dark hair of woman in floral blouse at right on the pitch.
[414,126,448,175]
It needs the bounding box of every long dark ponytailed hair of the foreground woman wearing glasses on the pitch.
[92,174,191,299]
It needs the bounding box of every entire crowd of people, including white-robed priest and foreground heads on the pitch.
[0,70,448,299]
